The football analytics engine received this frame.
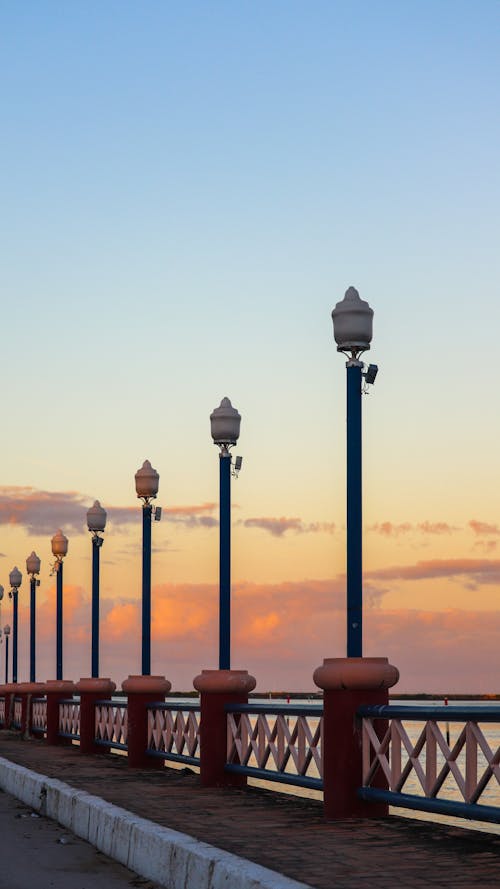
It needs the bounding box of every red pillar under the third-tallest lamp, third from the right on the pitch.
[122,676,172,769]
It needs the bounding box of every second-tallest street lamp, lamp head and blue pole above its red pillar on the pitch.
[210,398,241,670]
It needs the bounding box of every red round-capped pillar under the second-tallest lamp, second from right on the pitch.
[193,670,256,787]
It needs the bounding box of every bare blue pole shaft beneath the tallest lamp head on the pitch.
[347,362,363,657]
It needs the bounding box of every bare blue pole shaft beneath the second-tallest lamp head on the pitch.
[219,452,231,670]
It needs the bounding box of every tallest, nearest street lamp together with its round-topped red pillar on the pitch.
[314,287,399,819]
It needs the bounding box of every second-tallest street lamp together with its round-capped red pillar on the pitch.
[193,398,256,787]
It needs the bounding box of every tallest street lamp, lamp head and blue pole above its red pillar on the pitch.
[332,287,377,657]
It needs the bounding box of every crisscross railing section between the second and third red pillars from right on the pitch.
[148,703,200,765]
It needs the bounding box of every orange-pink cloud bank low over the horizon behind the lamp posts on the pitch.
[12,576,500,694]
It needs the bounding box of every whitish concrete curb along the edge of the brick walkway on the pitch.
[0,757,311,889]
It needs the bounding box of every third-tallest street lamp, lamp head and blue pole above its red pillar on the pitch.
[135,460,161,676]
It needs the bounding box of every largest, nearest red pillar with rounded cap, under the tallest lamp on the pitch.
[314,657,399,820]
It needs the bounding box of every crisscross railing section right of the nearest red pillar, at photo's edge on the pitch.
[358,705,500,823]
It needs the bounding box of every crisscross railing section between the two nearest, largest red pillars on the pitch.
[226,704,323,790]
